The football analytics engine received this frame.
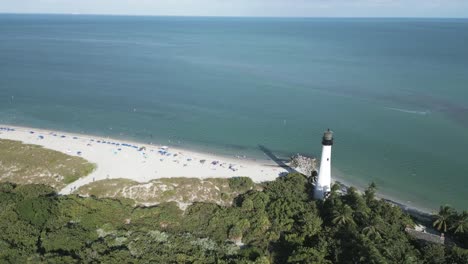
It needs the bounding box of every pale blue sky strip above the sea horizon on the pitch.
[0,0,468,18]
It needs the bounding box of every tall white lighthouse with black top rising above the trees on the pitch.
[314,129,333,200]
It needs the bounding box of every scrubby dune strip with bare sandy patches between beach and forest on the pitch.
[75,177,258,207]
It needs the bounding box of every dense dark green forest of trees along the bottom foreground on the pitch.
[0,174,468,263]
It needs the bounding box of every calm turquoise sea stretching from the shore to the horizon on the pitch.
[0,15,468,209]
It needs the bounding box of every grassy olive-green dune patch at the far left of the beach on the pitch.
[0,139,95,190]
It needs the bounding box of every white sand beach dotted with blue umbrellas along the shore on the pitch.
[0,124,287,194]
